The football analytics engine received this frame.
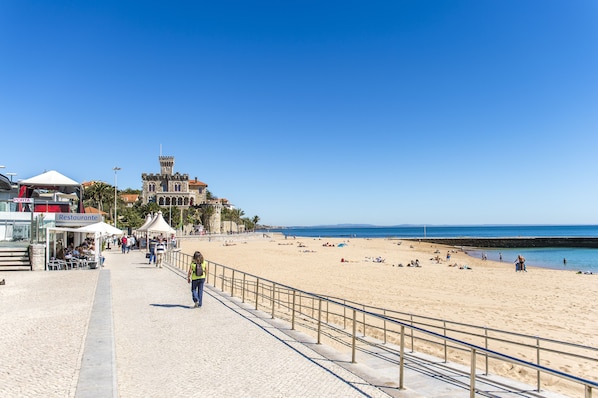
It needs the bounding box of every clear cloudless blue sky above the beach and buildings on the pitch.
[0,0,598,226]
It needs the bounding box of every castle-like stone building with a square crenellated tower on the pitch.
[141,156,208,208]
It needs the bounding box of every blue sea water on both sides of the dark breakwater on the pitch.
[267,225,598,274]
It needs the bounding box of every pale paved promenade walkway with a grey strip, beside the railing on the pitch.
[0,247,572,398]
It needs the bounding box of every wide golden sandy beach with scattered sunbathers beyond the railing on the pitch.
[181,234,598,396]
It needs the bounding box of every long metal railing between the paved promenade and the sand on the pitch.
[165,250,598,398]
